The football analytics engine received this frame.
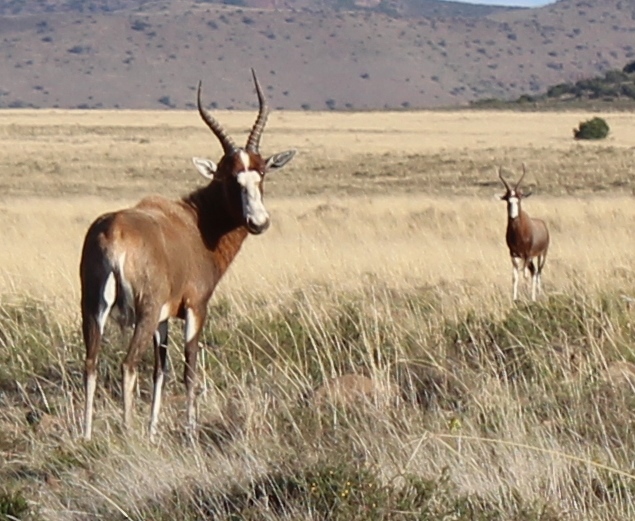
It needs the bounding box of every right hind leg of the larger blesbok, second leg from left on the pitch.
[121,309,159,429]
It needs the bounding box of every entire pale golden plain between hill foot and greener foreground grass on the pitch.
[0,107,635,303]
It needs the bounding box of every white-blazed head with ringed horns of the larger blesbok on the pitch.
[193,69,296,235]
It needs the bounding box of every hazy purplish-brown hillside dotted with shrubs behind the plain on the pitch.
[0,0,635,110]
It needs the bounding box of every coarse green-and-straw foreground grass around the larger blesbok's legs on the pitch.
[0,282,635,521]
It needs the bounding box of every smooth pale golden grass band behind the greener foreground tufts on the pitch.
[0,190,635,314]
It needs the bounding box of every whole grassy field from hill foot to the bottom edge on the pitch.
[0,107,635,521]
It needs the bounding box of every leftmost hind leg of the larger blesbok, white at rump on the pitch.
[82,273,116,441]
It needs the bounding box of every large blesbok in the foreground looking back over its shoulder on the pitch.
[80,69,295,440]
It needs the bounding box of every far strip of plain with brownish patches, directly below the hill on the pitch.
[0,111,635,199]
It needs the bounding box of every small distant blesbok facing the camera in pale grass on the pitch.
[498,165,549,301]
